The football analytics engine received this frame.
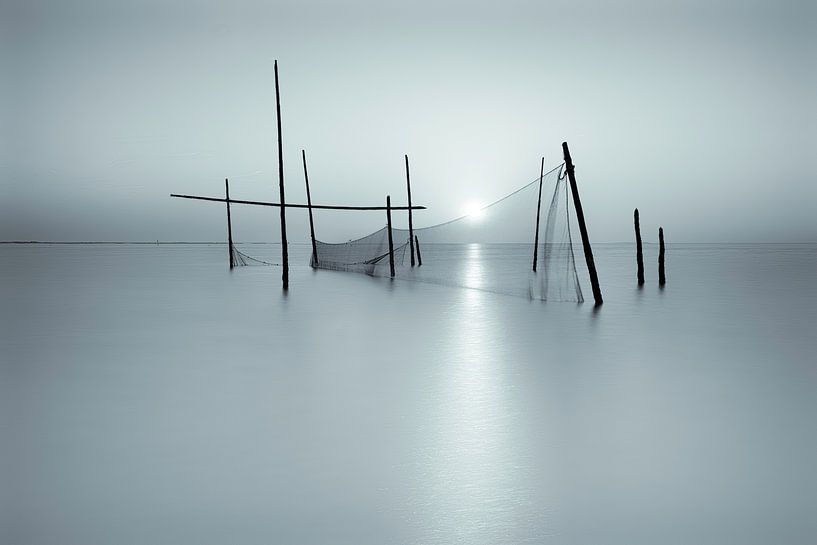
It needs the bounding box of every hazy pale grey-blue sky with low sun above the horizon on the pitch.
[0,0,817,241]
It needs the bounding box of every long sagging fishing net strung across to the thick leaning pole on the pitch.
[311,167,584,302]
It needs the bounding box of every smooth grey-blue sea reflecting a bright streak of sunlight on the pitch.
[0,244,817,545]
